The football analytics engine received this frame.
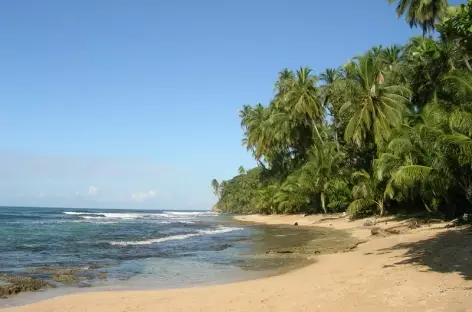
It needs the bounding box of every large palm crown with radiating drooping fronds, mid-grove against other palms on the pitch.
[340,53,410,146]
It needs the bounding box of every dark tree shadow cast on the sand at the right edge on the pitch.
[379,228,472,280]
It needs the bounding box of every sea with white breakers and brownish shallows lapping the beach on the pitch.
[0,208,352,306]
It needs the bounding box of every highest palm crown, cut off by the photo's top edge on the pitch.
[388,0,448,34]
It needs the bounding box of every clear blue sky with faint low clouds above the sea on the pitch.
[0,0,432,209]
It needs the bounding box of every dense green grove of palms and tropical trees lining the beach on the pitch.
[212,0,472,218]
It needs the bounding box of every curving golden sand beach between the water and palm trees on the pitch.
[0,215,472,312]
